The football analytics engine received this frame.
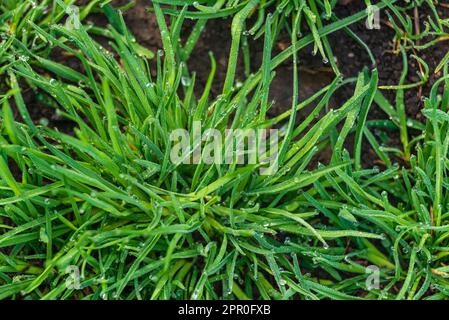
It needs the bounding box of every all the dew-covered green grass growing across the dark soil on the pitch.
[0,0,449,299]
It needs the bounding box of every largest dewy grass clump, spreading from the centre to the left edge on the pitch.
[0,1,382,299]
